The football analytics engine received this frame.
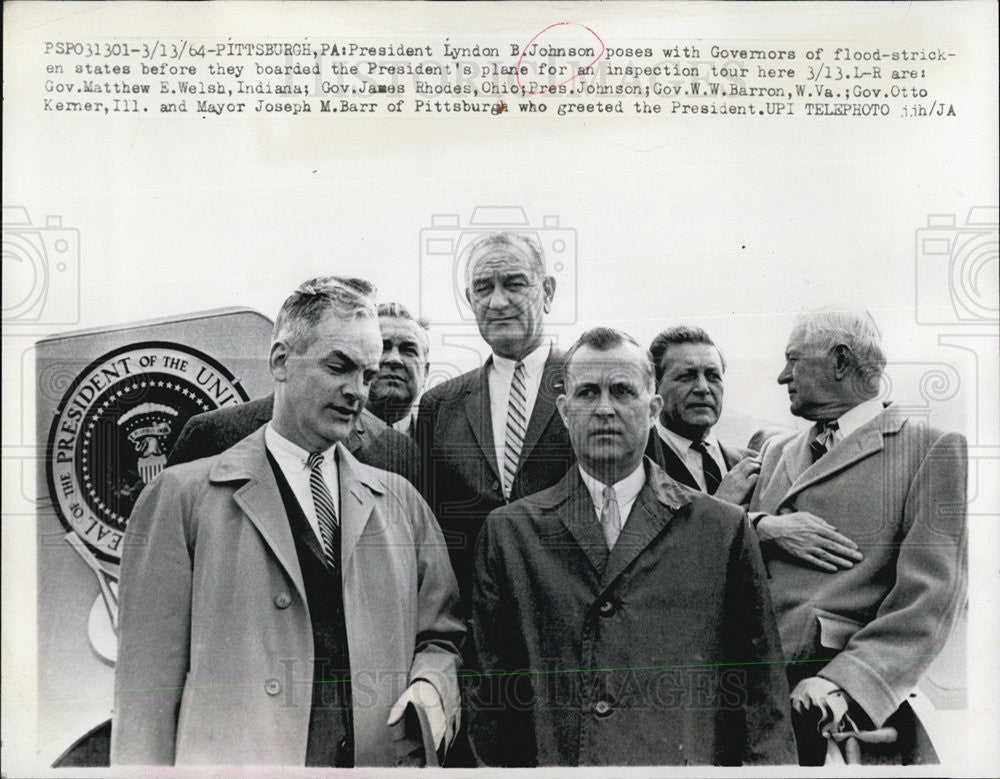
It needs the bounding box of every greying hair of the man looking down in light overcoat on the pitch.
[271,276,377,354]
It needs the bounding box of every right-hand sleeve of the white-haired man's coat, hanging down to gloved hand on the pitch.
[818,433,968,727]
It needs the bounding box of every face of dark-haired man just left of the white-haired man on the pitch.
[656,344,723,441]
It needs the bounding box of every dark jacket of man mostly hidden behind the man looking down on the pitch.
[167,395,420,485]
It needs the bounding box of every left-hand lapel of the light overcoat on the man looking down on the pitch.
[216,427,306,600]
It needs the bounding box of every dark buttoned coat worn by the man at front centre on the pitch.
[470,459,795,766]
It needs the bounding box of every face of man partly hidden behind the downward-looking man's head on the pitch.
[370,316,427,418]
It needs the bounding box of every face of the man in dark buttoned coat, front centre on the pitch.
[556,343,663,484]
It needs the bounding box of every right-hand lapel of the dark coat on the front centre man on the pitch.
[601,461,691,589]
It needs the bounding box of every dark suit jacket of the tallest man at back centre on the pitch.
[417,351,575,607]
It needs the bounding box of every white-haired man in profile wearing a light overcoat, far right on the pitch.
[750,311,967,765]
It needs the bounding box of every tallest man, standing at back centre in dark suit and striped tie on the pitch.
[417,233,573,607]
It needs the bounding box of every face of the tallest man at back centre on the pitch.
[465,244,556,360]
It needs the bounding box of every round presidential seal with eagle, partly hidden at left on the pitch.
[47,341,249,568]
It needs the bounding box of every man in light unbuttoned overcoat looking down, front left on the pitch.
[112,278,464,767]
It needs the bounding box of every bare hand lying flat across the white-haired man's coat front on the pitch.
[757,511,864,573]
